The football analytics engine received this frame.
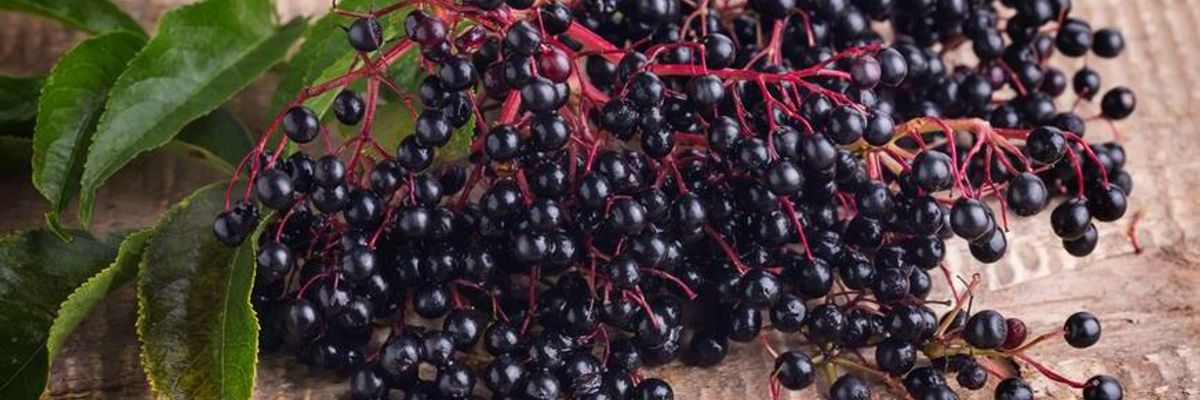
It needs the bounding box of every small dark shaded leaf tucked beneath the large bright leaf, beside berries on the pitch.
[175,108,254,173]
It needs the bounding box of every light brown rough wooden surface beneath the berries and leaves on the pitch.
[0,0,1200,399]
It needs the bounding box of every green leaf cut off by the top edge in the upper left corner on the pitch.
[0,0,145,36]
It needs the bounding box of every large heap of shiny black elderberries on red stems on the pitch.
[214,0,1136,400]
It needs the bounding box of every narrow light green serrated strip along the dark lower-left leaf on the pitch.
[46,229,154,363]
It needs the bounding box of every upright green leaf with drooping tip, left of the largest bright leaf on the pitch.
[34,31,145,236]
